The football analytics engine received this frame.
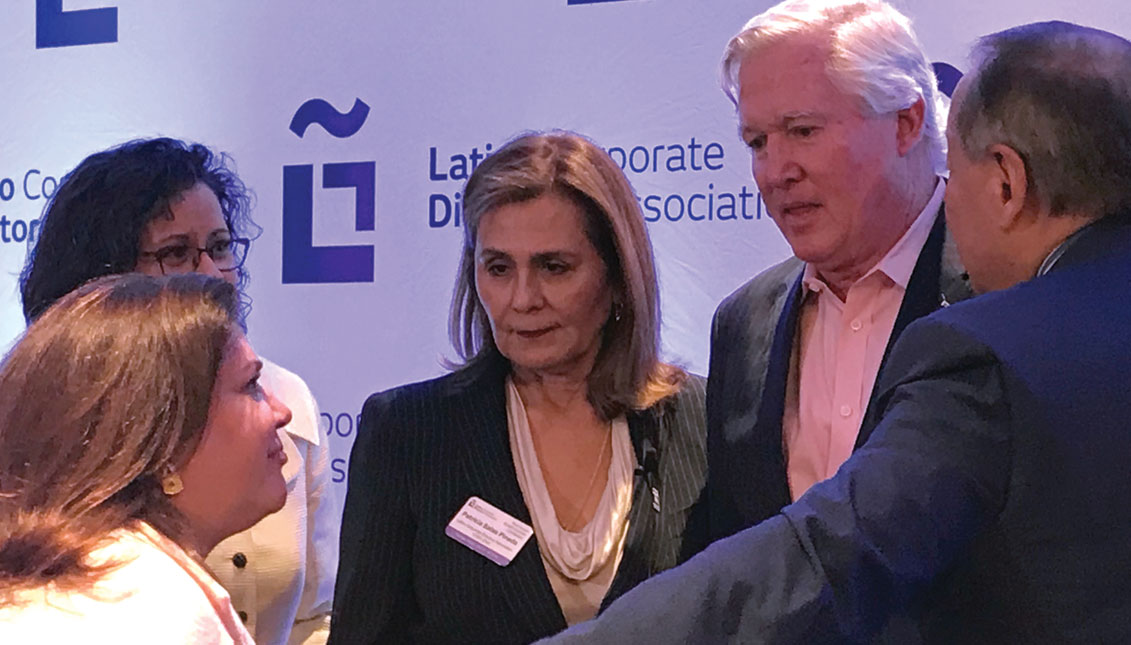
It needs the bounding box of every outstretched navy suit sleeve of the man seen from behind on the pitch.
[538,320,1011,643]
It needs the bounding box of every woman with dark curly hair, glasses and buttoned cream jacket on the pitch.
[20,138,338,644]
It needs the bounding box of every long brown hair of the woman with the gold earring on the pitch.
[0,274,238,607]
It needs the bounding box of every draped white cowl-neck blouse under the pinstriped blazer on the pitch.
[507,378,636,625]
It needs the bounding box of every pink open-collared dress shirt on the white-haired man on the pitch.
[782,180,946,500]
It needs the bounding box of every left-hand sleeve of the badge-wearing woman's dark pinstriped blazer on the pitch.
[330,394,418,645]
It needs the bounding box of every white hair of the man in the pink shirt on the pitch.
[723,0,947,172]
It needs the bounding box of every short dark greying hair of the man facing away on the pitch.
[955,22,1131,217]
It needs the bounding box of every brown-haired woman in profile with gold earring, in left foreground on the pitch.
[0,274,291,645]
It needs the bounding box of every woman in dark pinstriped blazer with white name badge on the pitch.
[330,132,706,645]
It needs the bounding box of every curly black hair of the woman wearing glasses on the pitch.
[19,138,259,321]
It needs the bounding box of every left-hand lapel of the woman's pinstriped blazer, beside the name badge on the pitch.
[450,361,566,634]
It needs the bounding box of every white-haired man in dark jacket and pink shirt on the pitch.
[699,0,970,548]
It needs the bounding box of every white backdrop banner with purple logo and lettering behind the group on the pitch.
[0,0,1131,482]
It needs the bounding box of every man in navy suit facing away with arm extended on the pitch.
[538,18,1131,643]
